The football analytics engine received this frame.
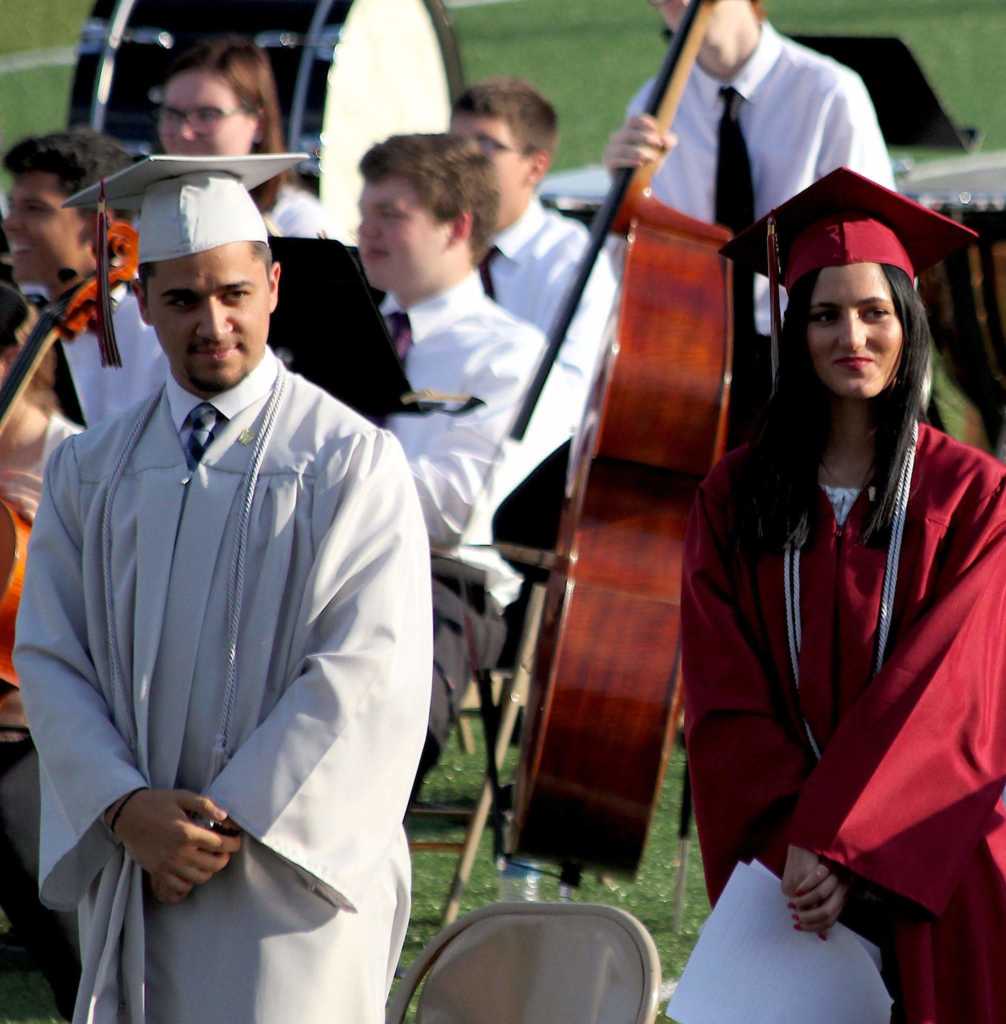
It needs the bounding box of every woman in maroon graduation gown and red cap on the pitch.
[682,169,1006,1024]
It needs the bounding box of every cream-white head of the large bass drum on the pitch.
[321,0,451,241]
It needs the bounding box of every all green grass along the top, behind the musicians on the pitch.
[0,0,1006,168]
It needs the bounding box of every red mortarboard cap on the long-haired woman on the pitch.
[722,167,977,289]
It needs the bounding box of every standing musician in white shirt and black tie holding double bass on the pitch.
[604,0,893,441]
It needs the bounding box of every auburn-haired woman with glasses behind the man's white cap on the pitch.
[157,36,342,238]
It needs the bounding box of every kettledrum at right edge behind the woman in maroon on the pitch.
[898,153,1006,459]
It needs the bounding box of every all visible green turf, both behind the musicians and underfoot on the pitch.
[0,0,1006,1024]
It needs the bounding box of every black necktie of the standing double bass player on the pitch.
[716,86,754,344]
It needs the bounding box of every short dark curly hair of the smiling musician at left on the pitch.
[3,127,133,196]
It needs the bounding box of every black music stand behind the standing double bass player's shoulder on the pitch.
[793,36,981,153]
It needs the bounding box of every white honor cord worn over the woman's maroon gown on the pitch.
[783,424,919,761]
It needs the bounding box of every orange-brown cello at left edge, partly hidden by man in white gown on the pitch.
[0,221,139,684]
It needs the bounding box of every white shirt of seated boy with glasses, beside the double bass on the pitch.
[490,198,618,423]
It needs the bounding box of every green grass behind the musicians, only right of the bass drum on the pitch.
[453,0,1006,168]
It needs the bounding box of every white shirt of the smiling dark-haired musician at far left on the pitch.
[60,286,170,427]
